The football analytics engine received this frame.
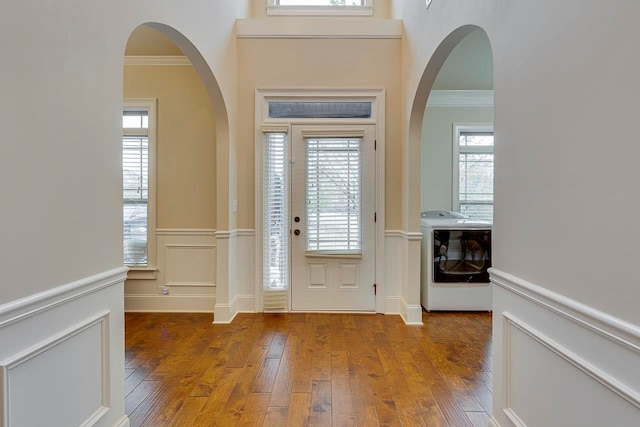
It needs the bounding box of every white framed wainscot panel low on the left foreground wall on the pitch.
[0,312,110,426]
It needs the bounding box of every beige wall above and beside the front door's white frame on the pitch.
[238,39,401,229]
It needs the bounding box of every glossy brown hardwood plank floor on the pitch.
[125,313,492,427]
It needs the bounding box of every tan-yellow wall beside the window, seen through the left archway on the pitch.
[123,66,216,229]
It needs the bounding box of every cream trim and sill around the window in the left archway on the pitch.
[121,98,158,280]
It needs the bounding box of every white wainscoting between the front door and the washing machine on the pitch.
[385,230,422,325]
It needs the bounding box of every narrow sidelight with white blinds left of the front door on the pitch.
[262,132,289,296]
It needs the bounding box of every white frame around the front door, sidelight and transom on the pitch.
[254,89,385,313]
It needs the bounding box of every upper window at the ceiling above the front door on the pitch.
[267,0,373,16]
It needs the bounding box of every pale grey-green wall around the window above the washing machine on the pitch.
[420,107,493,211]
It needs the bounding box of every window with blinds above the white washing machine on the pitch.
[453,125,493,222]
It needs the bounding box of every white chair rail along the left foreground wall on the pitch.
[0,267,128,328]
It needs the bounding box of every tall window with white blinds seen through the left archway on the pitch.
[122,100,155,267]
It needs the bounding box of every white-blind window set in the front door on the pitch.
[306,138,362,254]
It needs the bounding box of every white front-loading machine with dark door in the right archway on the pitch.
[420,211,493,311]
